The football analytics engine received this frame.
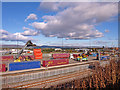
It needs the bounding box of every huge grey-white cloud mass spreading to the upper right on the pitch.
[30,2,118,39]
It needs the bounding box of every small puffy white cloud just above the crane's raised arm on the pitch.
[21,27,40,36]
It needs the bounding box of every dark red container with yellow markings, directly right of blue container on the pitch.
[43,59,69,67]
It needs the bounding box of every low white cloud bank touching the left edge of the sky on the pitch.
[0,29,33,42]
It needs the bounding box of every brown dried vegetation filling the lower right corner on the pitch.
[51,60,120,90]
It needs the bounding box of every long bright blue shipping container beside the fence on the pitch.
[9,61,41,71]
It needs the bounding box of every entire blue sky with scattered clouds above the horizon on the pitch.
[0,2,118,47]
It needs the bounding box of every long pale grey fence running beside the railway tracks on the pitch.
[2,64,89,84]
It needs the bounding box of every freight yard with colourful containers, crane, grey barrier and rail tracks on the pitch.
[0,42,118,88]
